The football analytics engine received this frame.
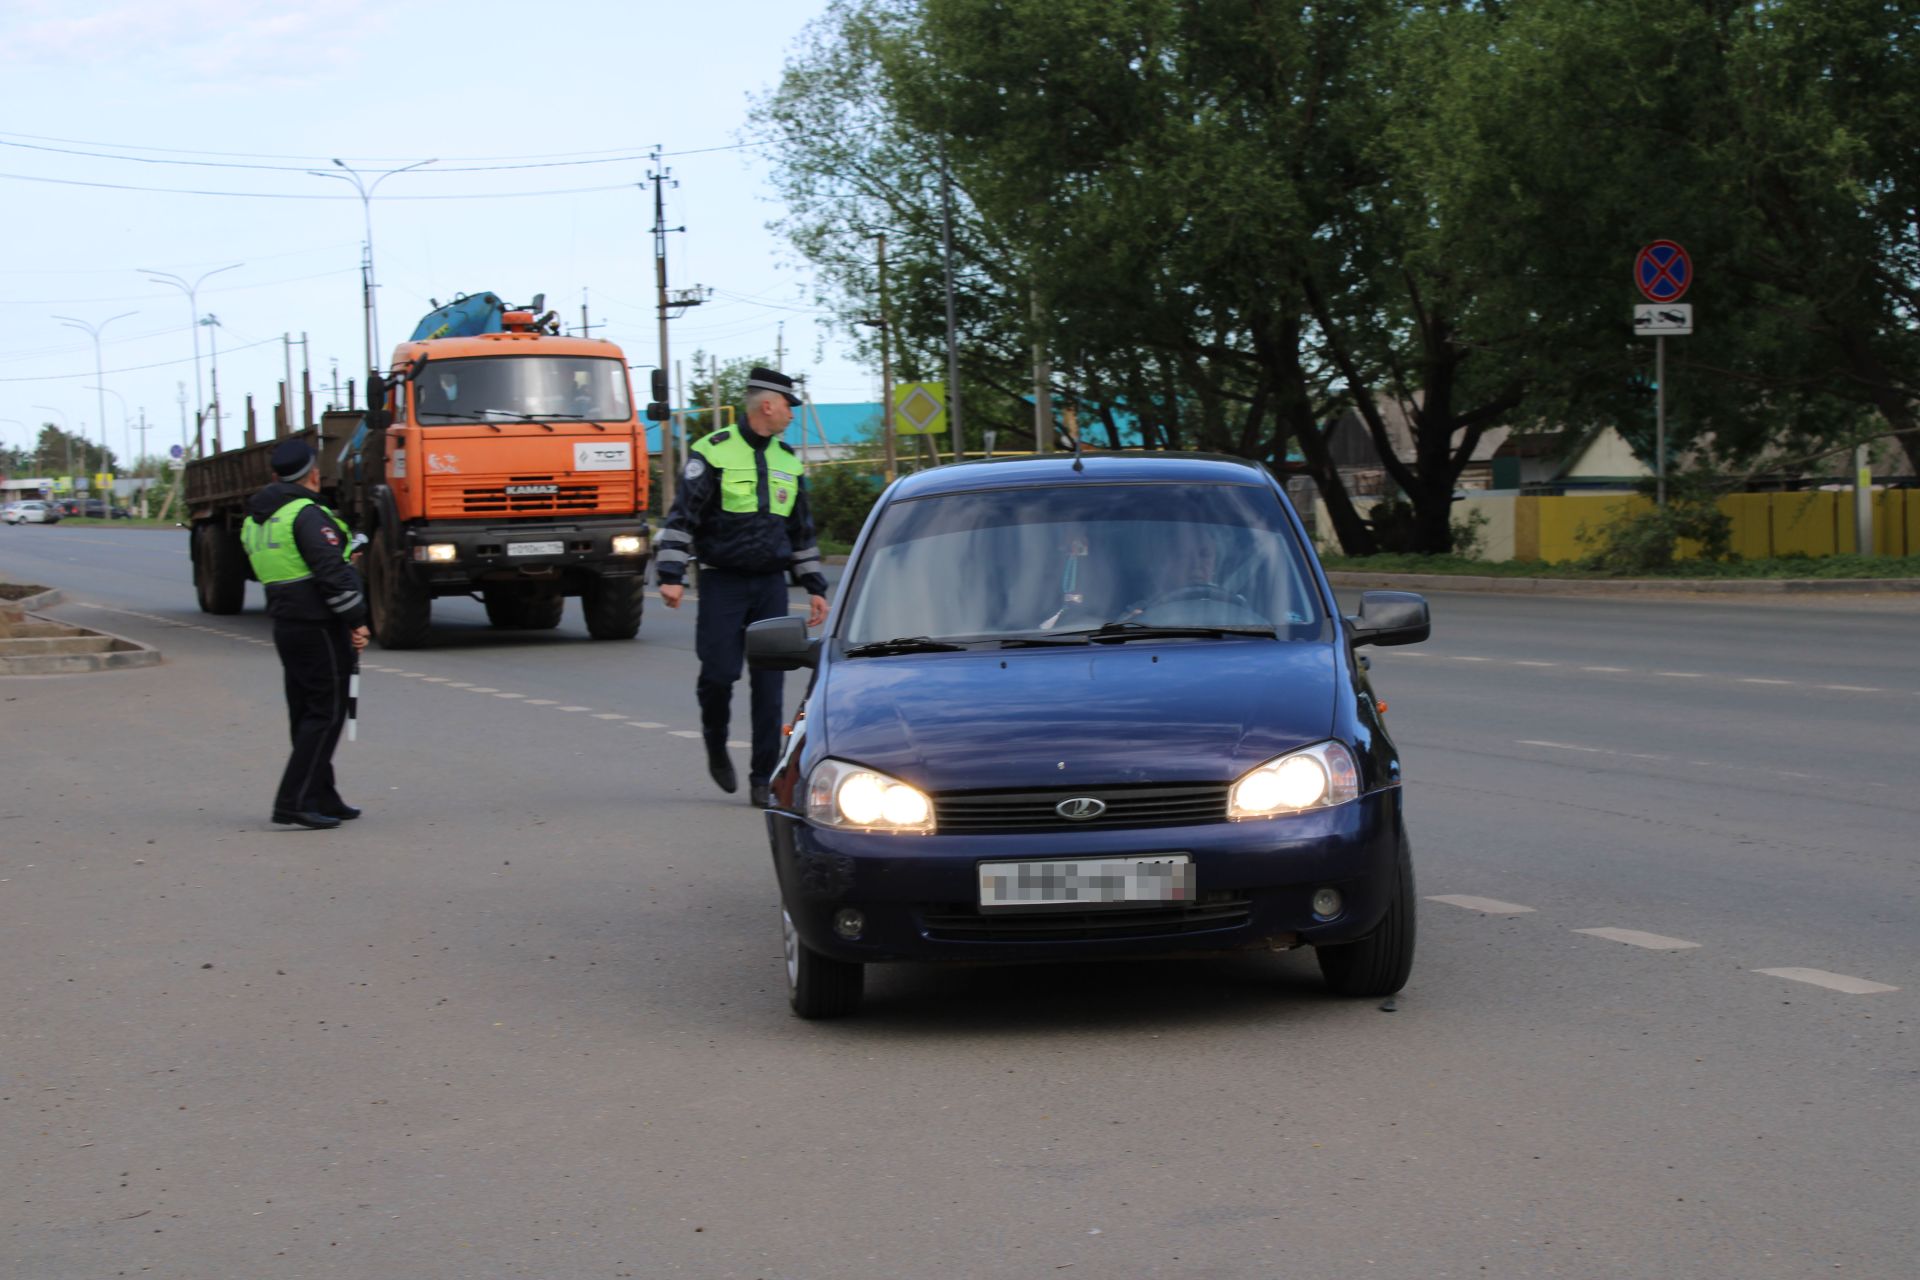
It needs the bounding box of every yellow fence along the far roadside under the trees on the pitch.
[1489,489,1920,562]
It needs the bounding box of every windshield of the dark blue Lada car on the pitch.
[839,484,1327,652]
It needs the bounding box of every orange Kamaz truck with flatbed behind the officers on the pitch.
[184,294,649,649]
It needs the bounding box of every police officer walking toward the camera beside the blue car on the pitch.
[653,368,828,806]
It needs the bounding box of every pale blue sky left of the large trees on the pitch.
[0,0,877,470]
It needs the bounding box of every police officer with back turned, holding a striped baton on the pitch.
[240,439,367,831]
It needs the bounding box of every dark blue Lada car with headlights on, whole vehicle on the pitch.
[747,455,1428,1017]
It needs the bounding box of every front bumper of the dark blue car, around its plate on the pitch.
[766,787,1402,961]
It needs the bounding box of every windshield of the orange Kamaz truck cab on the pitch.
[413,355,634,426]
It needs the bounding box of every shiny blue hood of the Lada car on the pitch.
[810,639,1338,791]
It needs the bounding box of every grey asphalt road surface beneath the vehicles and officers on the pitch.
[0,526,1920,1280]
